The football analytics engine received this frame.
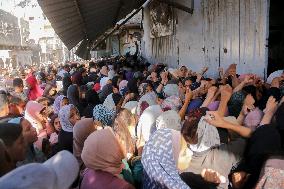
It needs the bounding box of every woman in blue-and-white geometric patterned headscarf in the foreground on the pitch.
[142,129,190,189]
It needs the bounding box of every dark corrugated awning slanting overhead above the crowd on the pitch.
[38,0,146,59]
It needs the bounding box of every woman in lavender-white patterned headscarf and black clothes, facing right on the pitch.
[58,104,80,153]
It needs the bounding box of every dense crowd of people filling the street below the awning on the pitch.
[0,56,284,189]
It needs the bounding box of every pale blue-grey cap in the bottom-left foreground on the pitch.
[0,151,79,189]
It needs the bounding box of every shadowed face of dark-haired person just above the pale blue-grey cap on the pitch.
[7,133,27,162]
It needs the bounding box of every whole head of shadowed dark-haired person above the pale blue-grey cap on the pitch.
[0,123,27,163]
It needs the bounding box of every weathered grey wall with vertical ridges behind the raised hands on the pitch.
[142,0,269,77]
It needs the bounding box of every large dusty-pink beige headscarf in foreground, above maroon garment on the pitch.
[81,127,125,176]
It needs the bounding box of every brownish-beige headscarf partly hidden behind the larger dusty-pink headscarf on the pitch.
[73,118,97,163]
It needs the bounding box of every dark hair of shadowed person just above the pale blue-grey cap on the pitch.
[0,123,22,147]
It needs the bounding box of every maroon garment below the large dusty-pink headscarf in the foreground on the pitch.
[80,169,134,189]
